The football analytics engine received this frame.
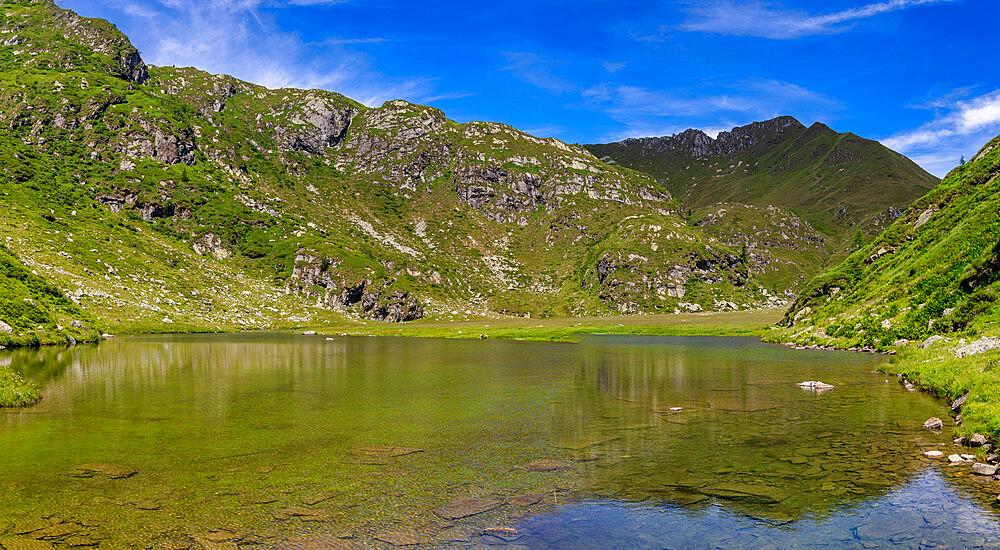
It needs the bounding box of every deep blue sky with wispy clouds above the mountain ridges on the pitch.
[57,0,1000,175]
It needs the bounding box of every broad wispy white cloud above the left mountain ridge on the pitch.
[67,0,442,106]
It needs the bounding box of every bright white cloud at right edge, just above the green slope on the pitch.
[882,88,1000,176]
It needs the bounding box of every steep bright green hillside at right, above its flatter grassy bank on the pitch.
[784,132,1000,349]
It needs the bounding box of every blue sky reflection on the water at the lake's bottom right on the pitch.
[518,469,1000,550]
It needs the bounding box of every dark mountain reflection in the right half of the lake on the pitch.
[553,338,938,519]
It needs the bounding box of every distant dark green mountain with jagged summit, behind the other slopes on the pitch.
[586,116,938,247]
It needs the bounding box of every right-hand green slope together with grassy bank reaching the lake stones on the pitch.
[769,138,1000,436]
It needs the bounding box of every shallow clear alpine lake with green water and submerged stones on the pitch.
[0,334,1000,550]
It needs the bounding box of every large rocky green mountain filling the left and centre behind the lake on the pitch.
[0,0,796,340]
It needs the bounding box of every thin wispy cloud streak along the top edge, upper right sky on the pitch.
[680,0,959,40]
